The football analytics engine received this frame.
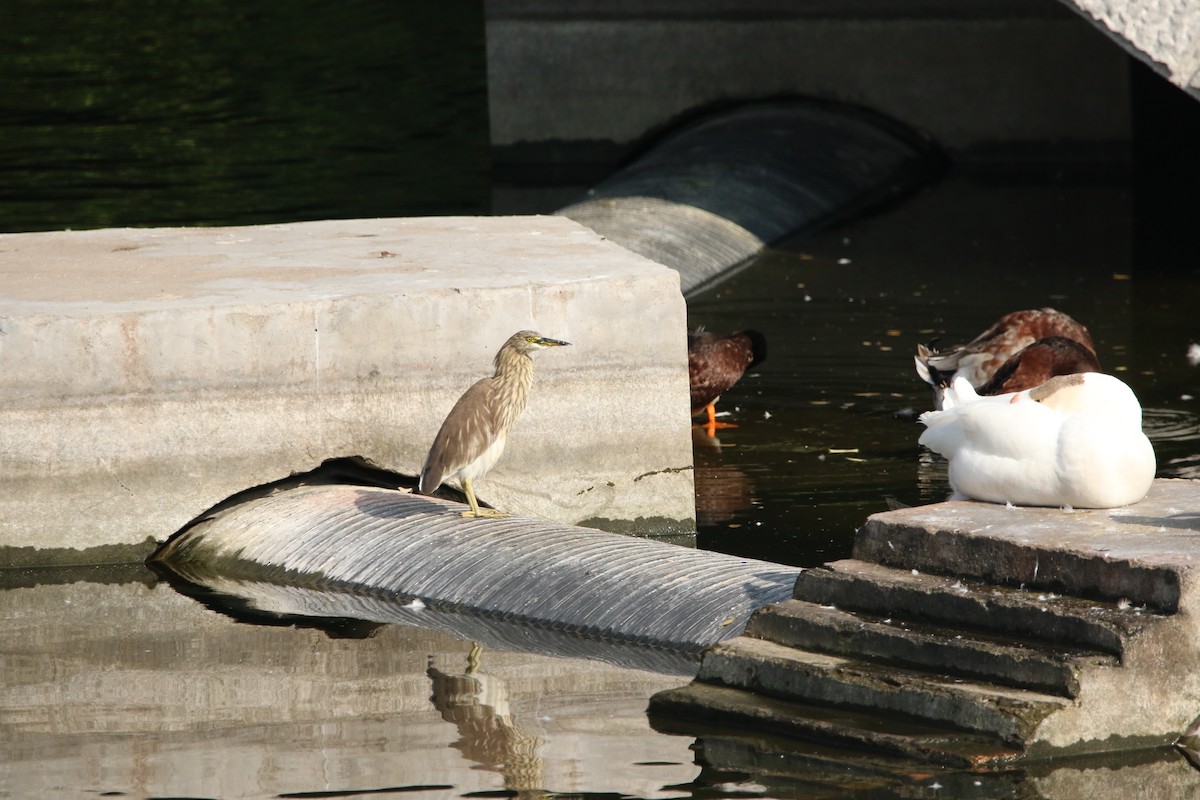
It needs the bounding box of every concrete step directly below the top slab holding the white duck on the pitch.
[796,559,1163,657]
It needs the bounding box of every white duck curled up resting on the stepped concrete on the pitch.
[919,372,1156,509]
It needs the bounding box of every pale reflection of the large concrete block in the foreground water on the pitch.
[0,570,697,800]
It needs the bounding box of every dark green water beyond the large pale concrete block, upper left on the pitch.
[0,0,490,231]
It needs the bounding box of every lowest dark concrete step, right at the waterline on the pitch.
[648,682,1020,767]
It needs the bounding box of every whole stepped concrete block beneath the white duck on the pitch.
[657,489,1200,760]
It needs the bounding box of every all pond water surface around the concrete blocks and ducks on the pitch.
[0,0,1200,800]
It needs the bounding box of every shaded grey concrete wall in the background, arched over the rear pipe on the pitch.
[487,0,1132,151]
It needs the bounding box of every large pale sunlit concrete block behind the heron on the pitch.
[0,217,695,564]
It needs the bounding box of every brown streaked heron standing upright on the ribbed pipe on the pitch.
[420,331,570,517]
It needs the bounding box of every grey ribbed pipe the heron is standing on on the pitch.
[155,486,800,650]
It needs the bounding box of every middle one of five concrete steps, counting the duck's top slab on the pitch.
[745,600,1117,698]
